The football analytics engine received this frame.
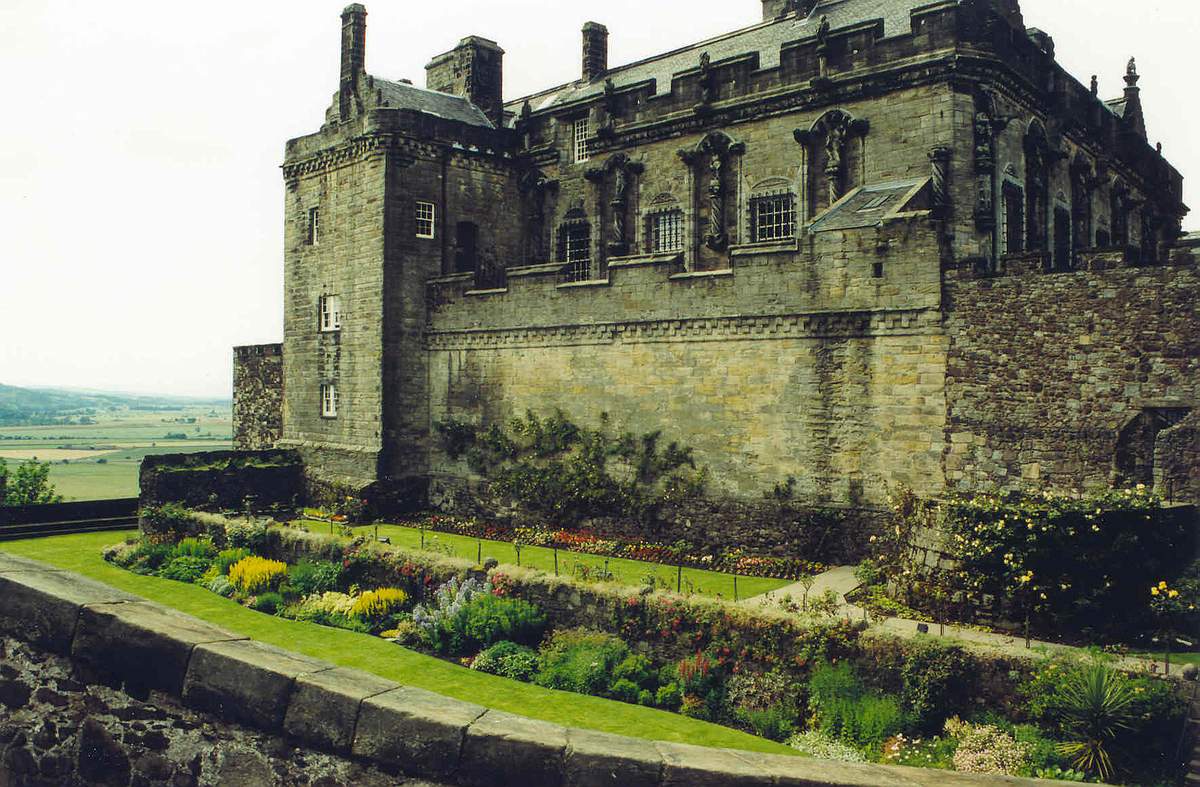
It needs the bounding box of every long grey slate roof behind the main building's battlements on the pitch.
[506,0,959,112]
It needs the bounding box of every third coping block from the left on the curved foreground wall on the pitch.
[177,641,334,731]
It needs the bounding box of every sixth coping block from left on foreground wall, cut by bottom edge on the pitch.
[458,710,566,787]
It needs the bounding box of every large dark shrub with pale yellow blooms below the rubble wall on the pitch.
[875,486,1194,639]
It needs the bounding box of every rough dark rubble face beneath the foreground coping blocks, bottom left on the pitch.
[0,637,408,787]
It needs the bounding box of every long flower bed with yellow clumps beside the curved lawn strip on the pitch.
[114,506,1182,783]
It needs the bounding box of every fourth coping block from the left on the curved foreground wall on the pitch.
[283,667,400,753]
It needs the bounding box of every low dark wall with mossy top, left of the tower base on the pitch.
[139,451,305,510]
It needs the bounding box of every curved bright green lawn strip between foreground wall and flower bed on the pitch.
[0,531,797,755]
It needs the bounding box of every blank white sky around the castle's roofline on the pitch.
[0,0,1200,396]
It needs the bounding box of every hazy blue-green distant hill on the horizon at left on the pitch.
[0,384,229,426]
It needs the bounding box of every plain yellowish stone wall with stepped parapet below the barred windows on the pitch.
[427,220,946,504]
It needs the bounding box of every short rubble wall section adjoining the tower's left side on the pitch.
[233,344,283,451]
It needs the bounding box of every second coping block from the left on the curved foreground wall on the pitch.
[71,601,245,697]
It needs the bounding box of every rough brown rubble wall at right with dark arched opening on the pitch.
[946,251,1200,501]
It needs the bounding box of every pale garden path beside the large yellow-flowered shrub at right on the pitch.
[742,566,1180,674]
